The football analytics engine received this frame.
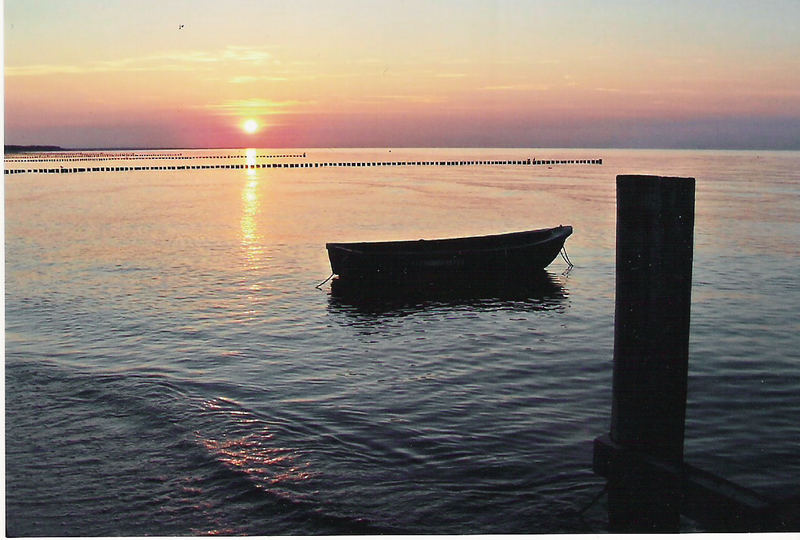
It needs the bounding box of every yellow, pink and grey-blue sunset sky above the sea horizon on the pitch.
[3,0,800,149]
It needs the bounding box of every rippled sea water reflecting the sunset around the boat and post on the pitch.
[5,149,800,535]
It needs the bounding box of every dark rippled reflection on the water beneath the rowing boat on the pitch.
[330,270,568,316]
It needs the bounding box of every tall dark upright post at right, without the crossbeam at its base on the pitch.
[609,175,695,532]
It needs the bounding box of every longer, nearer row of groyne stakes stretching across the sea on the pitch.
[3,155,603,174]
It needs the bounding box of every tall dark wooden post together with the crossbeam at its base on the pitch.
[593,175,800,533]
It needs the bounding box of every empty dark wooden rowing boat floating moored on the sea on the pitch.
[325,225,572,281]
